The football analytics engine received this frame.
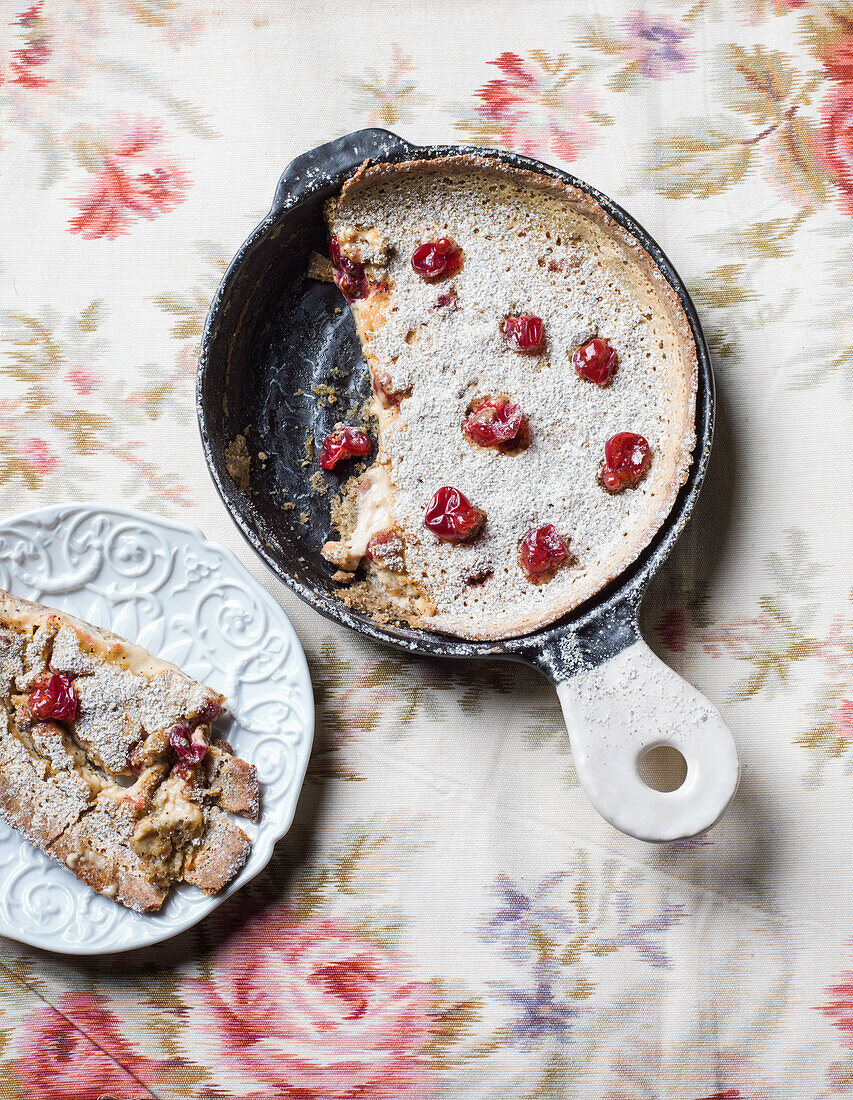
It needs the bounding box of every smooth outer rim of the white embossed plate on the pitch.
[0,501,315,956]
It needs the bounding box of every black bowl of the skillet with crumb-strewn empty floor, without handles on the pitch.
[198,137,713,664]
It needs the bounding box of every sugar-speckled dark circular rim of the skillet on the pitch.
[196,137,715,663]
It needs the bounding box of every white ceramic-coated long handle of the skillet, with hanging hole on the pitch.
[557,639,740,842]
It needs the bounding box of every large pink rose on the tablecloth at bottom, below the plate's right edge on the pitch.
[188,905,437,1100]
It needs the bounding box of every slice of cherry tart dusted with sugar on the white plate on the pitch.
[0,591,259,913]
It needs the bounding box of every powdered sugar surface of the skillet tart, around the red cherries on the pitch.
[330,157,696,638]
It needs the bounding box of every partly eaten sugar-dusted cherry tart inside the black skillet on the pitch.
[309,154,698,639]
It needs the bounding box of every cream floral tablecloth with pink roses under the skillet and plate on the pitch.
[0,0,853,1100]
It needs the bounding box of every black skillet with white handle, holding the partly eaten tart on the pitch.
[197,130,739,842]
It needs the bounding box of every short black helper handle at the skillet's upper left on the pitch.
[270,128,418,213]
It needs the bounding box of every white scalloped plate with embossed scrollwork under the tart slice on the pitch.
[0,505,314,955]
